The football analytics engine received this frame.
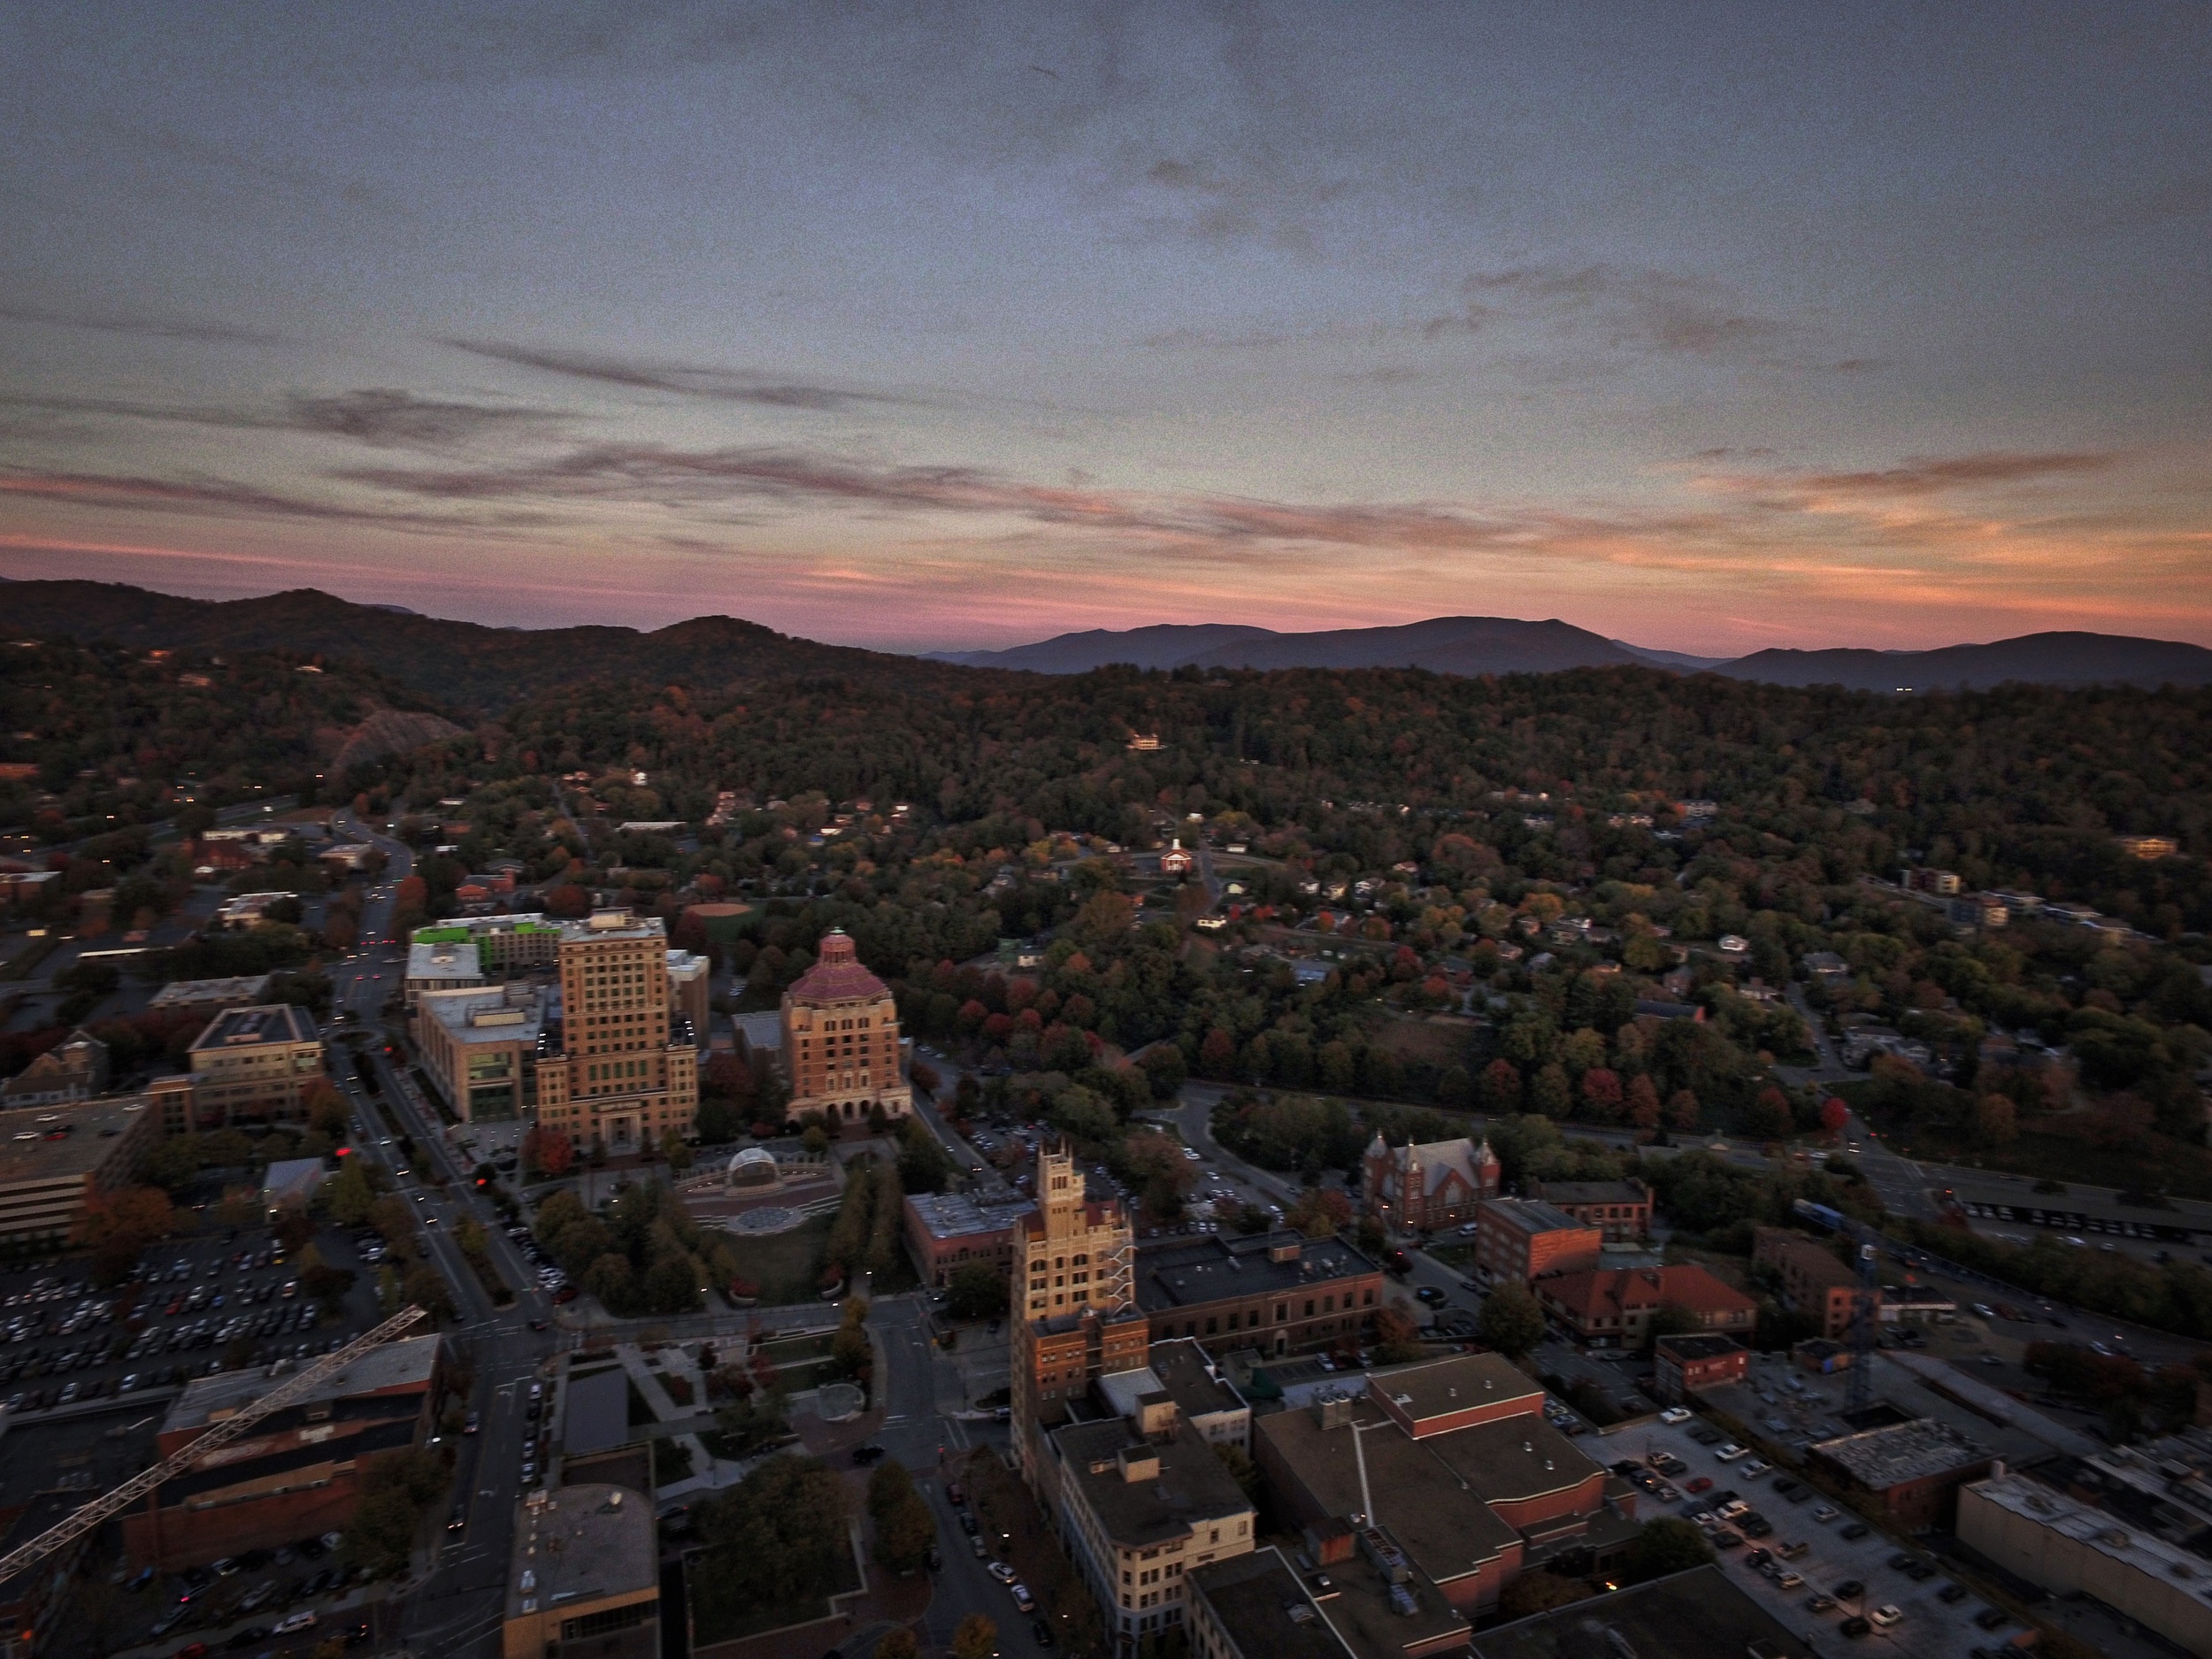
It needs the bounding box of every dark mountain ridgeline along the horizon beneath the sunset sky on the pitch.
[4,582,2212,710]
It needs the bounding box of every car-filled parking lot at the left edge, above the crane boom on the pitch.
[0,1228,376,1423]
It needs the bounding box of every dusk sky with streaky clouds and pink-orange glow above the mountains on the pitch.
[0,0,2212,655]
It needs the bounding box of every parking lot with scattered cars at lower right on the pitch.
[1610,1416,2020,1659]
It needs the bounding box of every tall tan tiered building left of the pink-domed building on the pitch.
[538,911,699,1155]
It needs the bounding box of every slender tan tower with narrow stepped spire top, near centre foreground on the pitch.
[1011,1148,1150,1498]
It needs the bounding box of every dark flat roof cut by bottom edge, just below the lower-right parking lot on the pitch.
[1473,1566,1814,1659]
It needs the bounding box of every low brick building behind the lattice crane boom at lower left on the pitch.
[122,1336,441,1573]
